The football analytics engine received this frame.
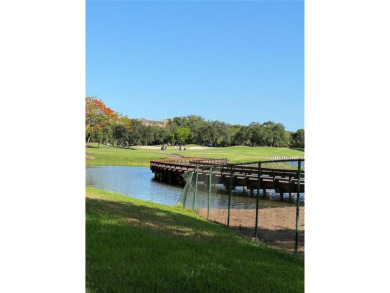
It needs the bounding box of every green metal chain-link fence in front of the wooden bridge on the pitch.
[178,159,305,253]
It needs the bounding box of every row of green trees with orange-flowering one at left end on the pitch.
[86,97,305,148]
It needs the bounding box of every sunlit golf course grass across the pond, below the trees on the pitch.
[86,144,305,166]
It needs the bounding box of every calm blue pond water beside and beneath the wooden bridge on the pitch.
[86,166,304,209]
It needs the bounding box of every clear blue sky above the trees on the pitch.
[86,0,304,131]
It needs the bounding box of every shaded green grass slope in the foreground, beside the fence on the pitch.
[86,187,304,292]
